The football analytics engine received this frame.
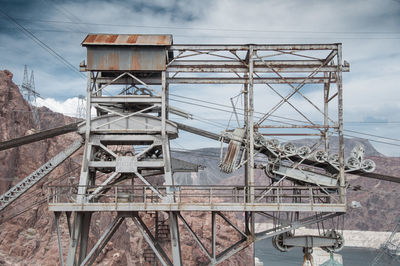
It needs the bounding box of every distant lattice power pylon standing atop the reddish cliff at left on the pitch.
[20,65,40,126]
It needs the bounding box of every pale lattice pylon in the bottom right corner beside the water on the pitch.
[371,217,400,266]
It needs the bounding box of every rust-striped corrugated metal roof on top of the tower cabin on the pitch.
[82,34,172,46]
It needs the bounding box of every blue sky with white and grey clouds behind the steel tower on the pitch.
[0,0,400,156]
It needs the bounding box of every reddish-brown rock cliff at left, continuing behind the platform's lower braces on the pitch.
[0,70,252,265]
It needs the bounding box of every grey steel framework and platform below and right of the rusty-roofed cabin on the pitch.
[49,40,349,265]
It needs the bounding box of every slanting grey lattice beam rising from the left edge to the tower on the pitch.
[0,140,82,211]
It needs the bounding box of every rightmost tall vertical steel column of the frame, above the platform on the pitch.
[336,44,346,203]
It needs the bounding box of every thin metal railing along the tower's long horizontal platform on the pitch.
[48,185,340,204]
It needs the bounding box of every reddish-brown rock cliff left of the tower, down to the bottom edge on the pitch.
[0,70,79,265]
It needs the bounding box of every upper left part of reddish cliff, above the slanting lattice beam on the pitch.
[0,70,78,193]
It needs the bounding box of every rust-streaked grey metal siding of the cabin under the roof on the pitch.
[87,46,166,71]
